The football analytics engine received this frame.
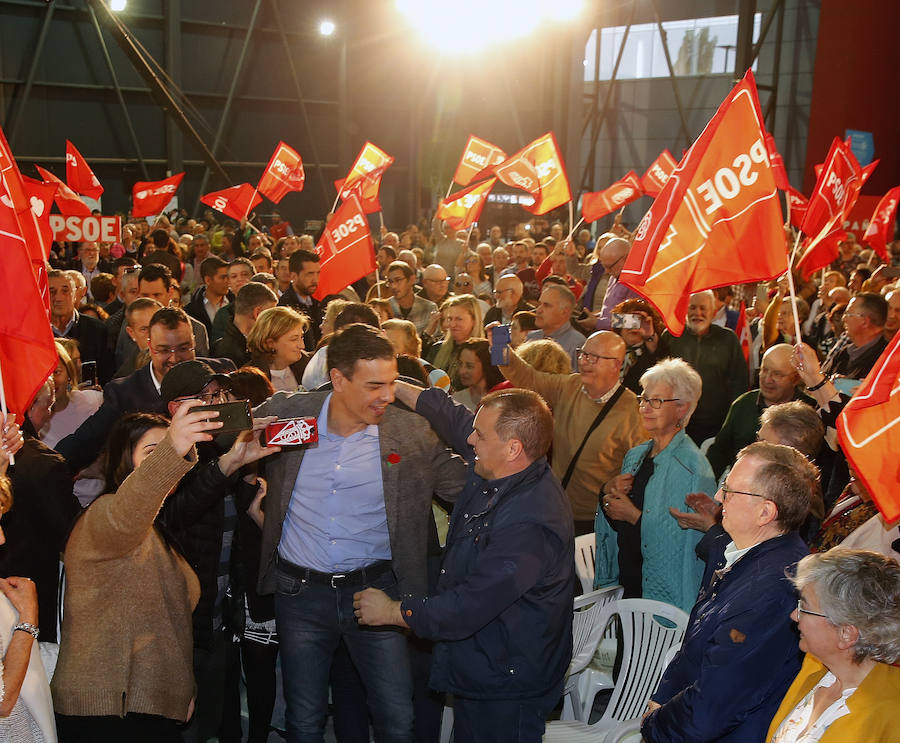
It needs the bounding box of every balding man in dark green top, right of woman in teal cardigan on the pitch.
[706,343,816,478]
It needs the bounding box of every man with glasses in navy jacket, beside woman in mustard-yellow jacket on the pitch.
[641,442,818,743]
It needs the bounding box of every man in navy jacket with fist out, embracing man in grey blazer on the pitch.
[354,382,575,743]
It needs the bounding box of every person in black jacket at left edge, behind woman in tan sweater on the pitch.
[0,381,81,642]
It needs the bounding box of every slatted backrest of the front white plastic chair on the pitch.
[603,599,688,721]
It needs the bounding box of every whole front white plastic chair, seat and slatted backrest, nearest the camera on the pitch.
[544,599,688,743]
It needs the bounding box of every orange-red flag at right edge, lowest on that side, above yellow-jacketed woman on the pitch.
[837,333,900,522]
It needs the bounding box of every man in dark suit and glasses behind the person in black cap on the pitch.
[56,307,235,472]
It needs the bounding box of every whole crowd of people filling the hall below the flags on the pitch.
[0,205,900,743]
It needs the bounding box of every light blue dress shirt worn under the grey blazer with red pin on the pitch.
[278,395,391,573]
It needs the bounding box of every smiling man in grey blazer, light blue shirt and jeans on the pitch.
[255,324,466,739]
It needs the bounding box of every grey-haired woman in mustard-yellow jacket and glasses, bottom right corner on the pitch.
[766,548,900,743]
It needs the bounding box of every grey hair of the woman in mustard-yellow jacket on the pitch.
[791,547,900,663]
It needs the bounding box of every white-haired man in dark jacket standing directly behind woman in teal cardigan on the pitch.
[664,290,748,446]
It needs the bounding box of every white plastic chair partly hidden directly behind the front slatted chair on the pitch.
[562,586,624,722]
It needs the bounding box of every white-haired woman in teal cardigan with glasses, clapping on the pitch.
[596,359,716,611]
